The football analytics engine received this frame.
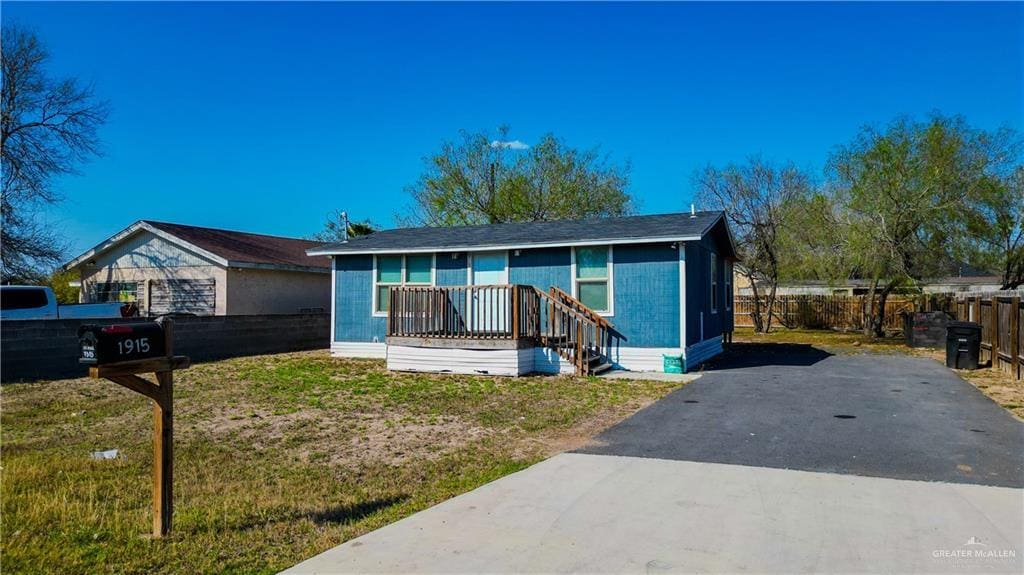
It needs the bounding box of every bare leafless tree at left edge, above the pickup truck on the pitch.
[0,25,108,281]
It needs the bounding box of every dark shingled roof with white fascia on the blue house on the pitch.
[307,212,735,257]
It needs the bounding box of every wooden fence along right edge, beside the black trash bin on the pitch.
[956,295,1024,380]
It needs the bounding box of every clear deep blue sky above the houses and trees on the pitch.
[2,2,1024,252]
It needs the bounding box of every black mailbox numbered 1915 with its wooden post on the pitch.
[79,317,190,537]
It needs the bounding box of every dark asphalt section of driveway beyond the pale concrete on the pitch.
[581,344,1024,487]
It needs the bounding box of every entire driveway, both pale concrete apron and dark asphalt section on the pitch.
[288,345,1024,575]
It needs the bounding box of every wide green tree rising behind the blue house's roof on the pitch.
[398,127,633,226]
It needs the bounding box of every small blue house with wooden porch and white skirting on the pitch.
[307,212,736,375]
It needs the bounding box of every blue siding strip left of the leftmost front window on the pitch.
[334,256,386,342]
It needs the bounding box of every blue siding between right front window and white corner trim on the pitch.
[608,244,679,348]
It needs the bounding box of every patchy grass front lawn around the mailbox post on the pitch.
[6,352,679,573]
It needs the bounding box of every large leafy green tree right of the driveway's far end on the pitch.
[828,115,1000,336]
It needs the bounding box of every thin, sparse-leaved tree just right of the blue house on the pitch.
[694,159,810,333]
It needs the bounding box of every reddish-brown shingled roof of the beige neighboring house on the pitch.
[65,220,330,272]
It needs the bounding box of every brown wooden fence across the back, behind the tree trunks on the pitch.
[734,295,925,330]
